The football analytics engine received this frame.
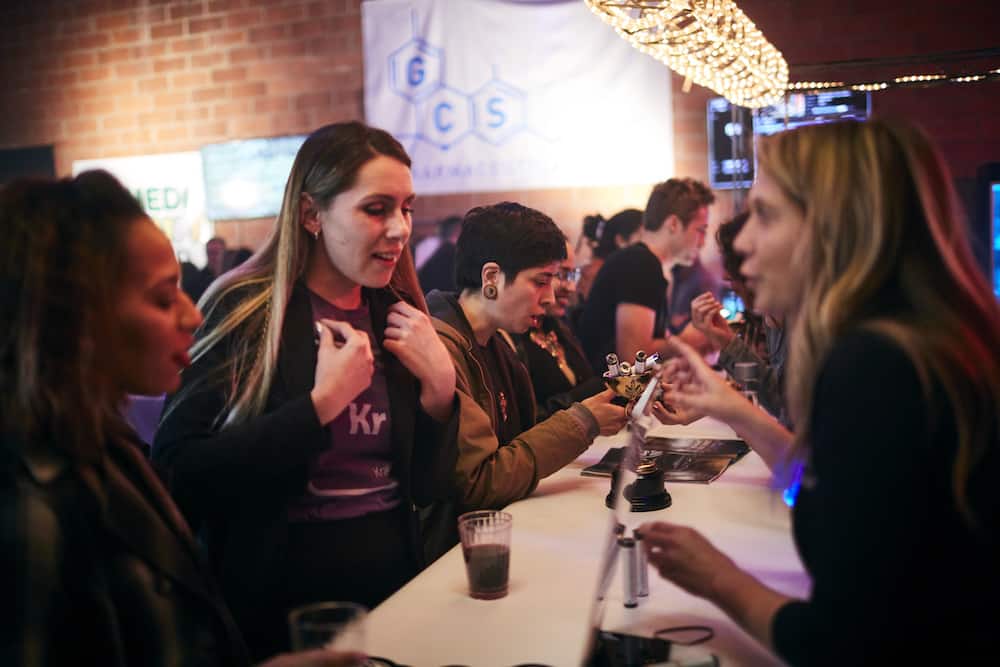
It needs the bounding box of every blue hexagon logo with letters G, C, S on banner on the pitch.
[388,37,527,150]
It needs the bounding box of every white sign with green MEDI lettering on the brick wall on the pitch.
[73,151,214,266]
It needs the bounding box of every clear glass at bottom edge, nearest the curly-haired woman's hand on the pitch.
[288,602,368,653]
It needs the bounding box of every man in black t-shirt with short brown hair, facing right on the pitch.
[578,178,715,372]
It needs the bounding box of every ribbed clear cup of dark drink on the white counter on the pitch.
[458,510,514,600]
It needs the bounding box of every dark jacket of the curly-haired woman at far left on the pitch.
[0,439,249,667]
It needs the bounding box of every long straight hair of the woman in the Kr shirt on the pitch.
[174,122,426,426]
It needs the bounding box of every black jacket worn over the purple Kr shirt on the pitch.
[152,283,459,657]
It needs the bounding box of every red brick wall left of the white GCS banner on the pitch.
[0,0,362,246]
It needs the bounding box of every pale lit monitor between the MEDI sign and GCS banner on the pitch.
[201,135,306,220]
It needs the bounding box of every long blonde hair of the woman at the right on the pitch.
[757,120,1000,522]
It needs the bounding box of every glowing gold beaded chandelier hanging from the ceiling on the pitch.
[584,0,788,108]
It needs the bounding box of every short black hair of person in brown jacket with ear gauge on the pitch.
[455,202,566,290]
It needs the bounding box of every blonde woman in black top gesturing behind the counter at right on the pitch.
[644,121,1000,665]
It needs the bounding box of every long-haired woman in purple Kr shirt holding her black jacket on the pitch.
[153,123,457,655]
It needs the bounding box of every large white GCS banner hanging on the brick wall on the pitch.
[362,0,674,194]
